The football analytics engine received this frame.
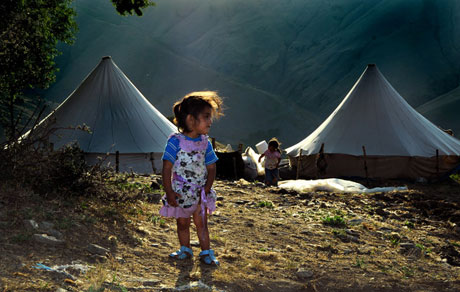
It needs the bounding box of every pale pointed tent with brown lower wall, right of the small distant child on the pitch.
[286,64,460,178]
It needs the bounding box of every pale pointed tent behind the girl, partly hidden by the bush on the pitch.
[29,57,177,173]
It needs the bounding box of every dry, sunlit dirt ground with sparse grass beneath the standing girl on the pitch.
[0,178,460,292]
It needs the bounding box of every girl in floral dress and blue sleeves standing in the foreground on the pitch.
[160,91,222,265]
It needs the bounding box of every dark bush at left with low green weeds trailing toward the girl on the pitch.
[0,127,160,201]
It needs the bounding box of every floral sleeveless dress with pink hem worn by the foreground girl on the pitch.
[160,134,217,218]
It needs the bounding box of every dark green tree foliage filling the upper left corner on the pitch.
[0,0,77,139]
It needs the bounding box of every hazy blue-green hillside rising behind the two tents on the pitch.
[40,0,460,146]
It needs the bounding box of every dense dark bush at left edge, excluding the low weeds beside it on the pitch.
[0,141,104,196]
